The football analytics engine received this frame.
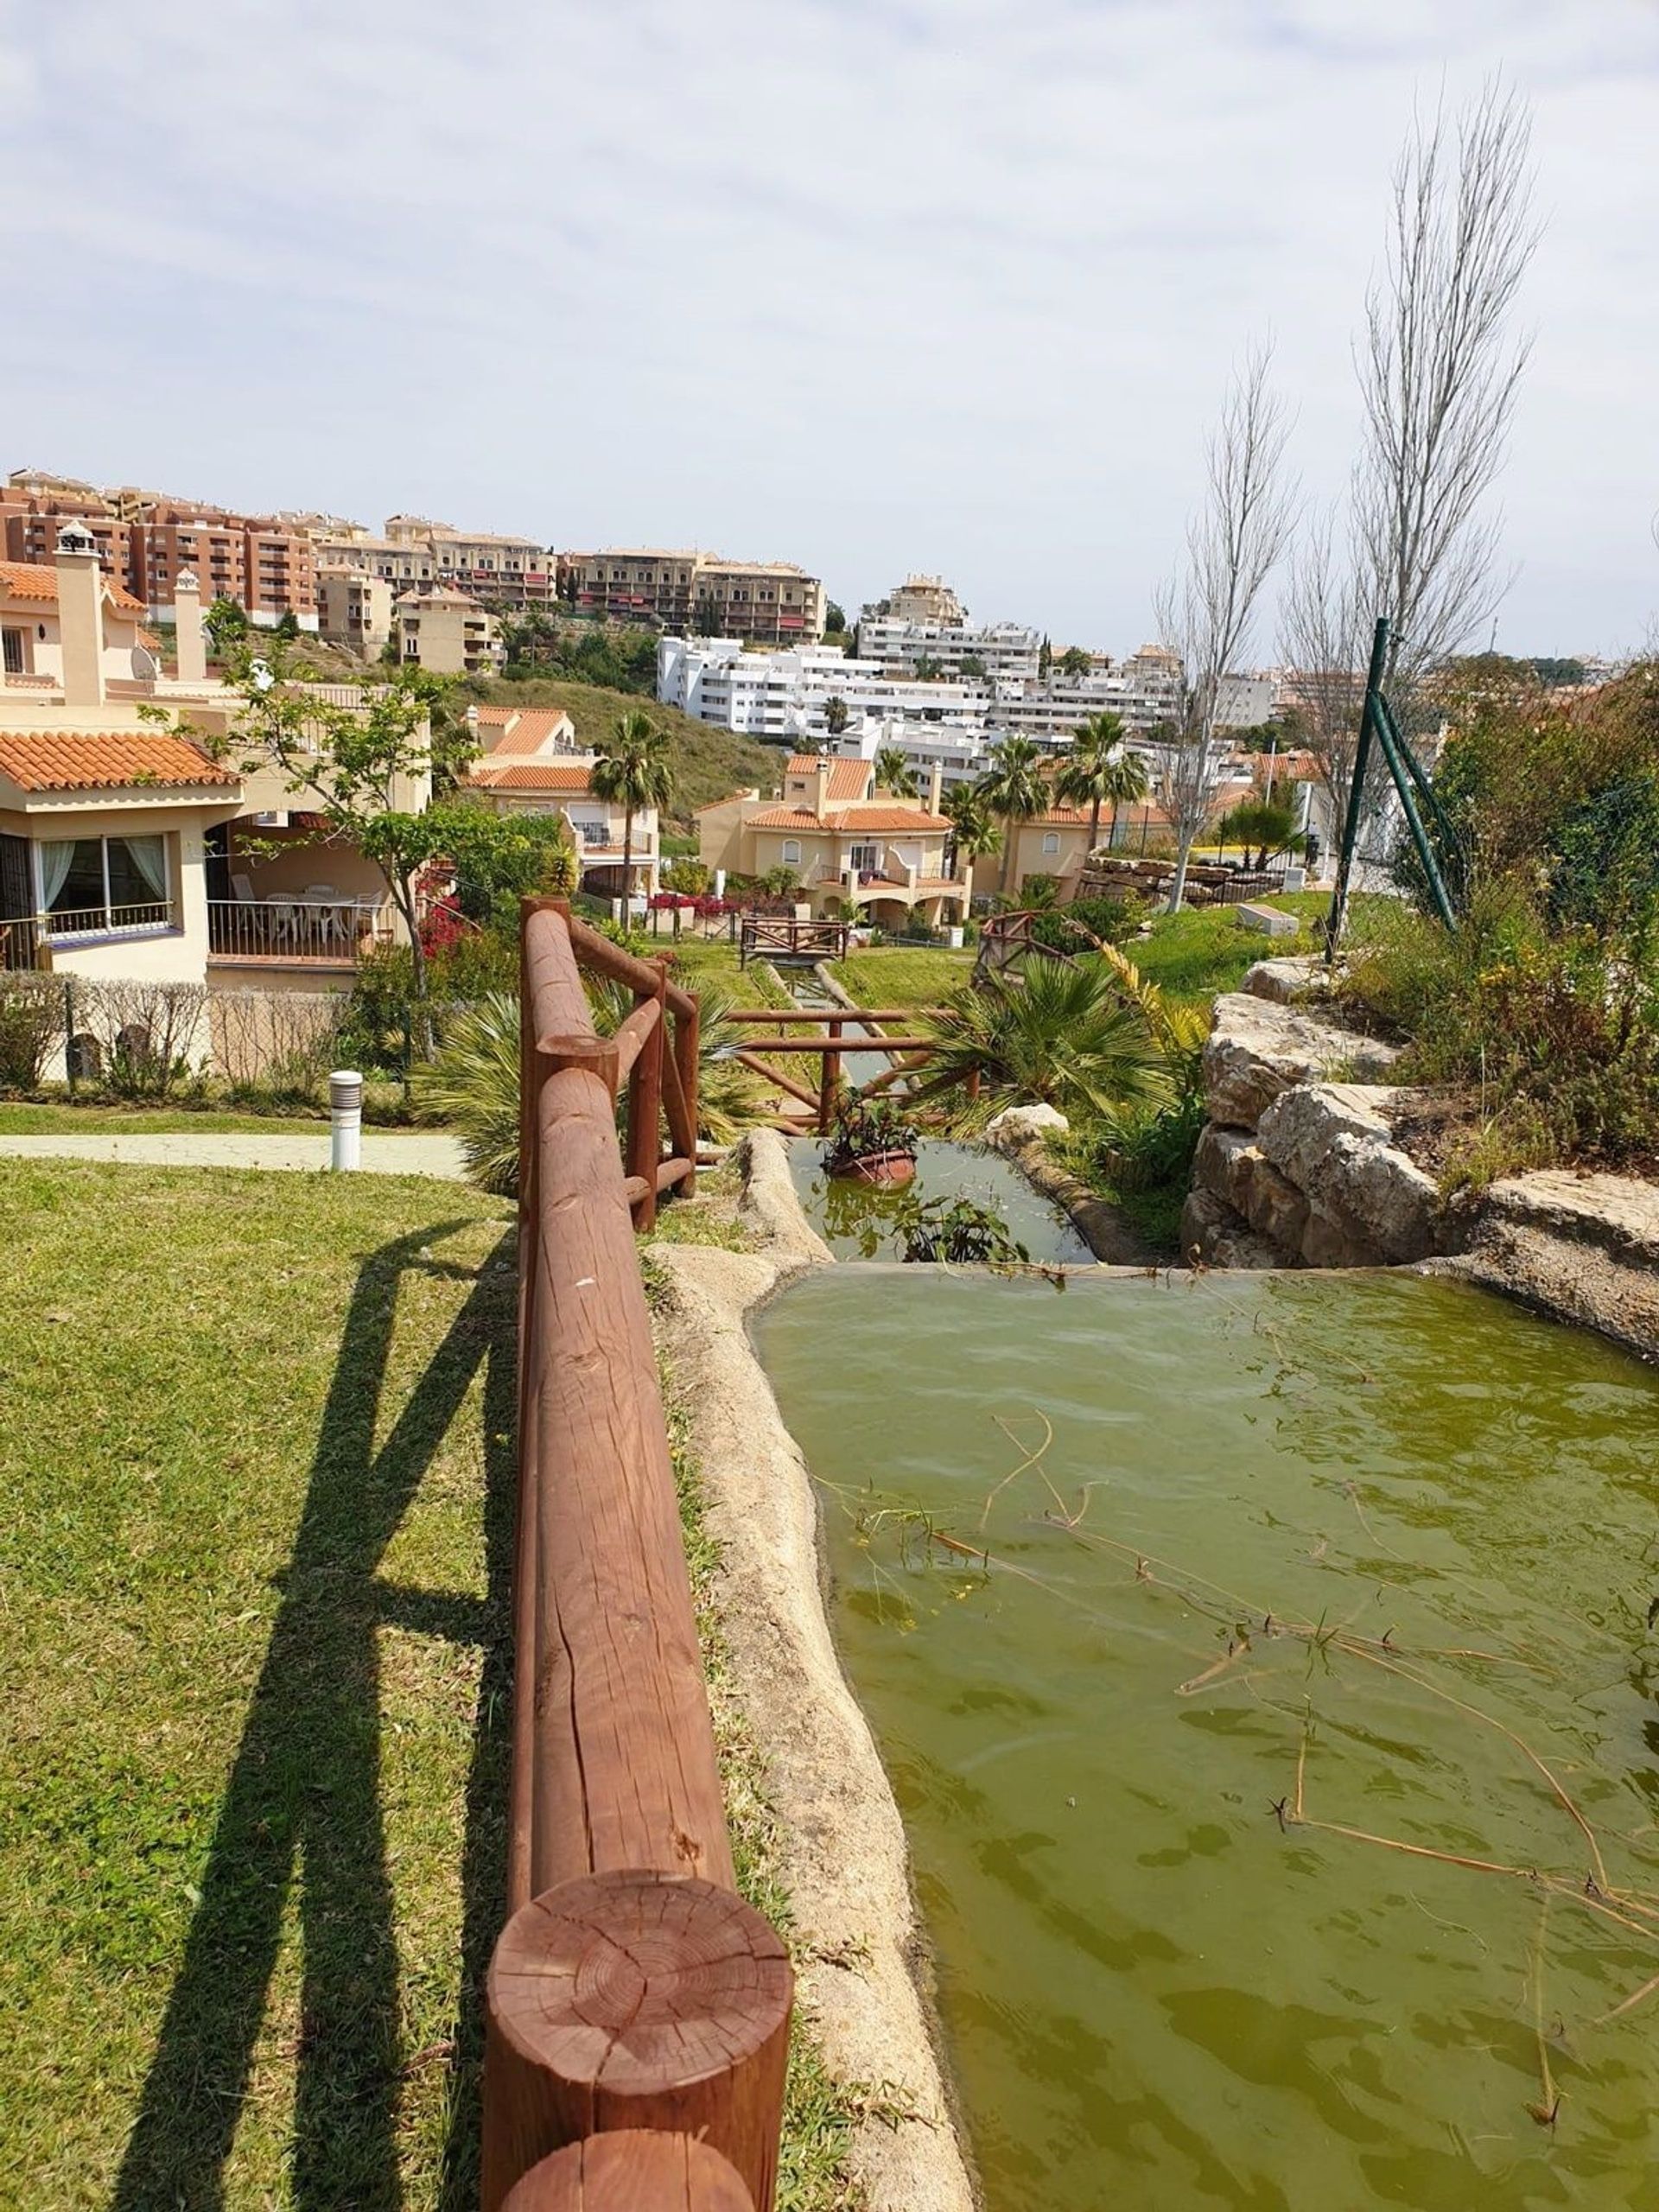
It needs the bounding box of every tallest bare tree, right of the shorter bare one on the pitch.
[1281,79,1537,854]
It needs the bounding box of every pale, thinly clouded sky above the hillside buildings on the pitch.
[0,0,1659,664]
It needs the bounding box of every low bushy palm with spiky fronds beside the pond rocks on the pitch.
[927,960,1173,1128]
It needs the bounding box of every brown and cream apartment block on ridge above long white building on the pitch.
[560,546,825,646]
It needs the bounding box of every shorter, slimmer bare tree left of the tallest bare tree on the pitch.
[1153,345,1296,913]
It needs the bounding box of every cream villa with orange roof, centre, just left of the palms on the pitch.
[696,752,969,927]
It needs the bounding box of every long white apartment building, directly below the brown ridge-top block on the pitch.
[657,637,991,746]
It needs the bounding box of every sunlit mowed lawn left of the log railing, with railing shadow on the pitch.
[0,1161,513,2212]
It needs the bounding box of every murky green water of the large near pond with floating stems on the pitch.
[757,1268,1659,2212]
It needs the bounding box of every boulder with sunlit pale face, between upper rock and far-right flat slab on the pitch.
[1256,1084,1442,1268]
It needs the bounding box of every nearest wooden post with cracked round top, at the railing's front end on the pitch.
[482,1872,794,2212]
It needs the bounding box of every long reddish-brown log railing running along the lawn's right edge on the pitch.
[480,900,791,2212]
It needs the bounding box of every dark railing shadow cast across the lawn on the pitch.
[111,1224,515,2212]
